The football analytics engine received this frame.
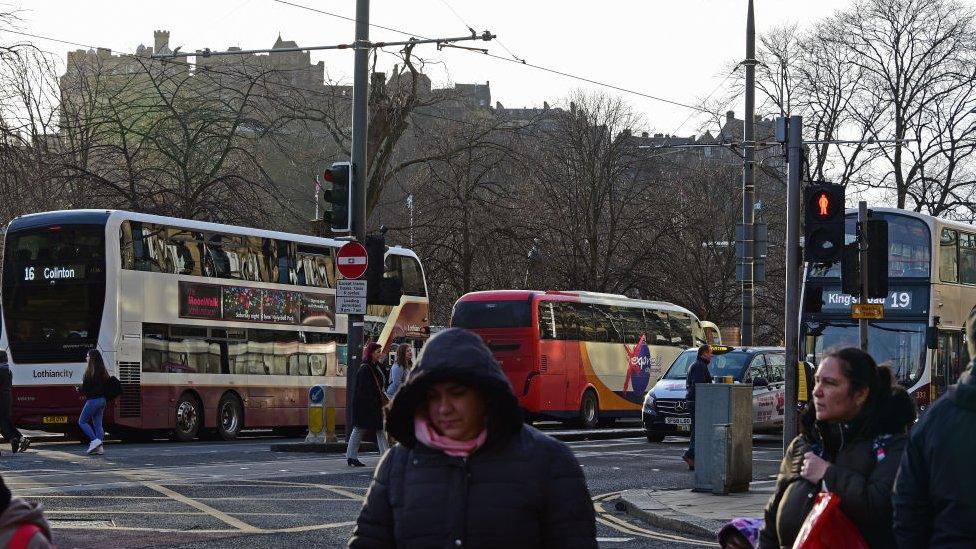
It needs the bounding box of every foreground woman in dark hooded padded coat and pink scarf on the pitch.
[349,328,597,549]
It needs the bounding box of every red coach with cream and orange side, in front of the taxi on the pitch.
[451,290,705,428]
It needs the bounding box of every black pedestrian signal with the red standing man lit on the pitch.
[803,183,844,263]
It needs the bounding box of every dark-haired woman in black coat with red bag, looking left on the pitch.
[759,347,915,549]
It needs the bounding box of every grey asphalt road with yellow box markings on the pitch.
[0,437,780,549]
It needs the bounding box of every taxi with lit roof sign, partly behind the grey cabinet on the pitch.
[642,345,786,442]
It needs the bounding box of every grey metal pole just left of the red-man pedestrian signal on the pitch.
[783,116,803,451]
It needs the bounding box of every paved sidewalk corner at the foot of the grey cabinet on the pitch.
[620,481,774,539]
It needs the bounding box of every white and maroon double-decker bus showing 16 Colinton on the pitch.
[0,210,429,440]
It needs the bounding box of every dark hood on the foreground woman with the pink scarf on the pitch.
[386,328,522,448]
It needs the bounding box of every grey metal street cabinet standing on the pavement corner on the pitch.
[694,383,752,494]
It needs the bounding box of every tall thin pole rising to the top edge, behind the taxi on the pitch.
[740,0,756,345]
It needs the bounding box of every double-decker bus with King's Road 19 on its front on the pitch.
[800,208,976,409]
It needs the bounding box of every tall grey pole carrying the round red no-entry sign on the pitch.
[346,0,369,426]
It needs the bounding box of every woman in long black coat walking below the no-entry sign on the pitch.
[346,342,389,467]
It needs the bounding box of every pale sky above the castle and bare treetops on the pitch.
[7,0,850,135]
